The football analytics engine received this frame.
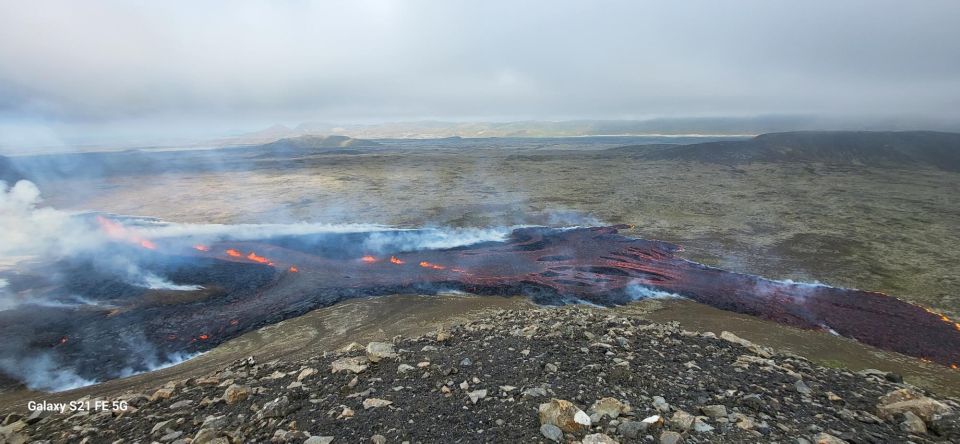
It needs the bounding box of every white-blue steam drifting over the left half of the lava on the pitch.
[0,181,515,391]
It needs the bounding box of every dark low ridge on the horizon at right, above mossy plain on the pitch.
[607,131,960,171]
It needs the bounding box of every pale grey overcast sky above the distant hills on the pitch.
[0,0,960,149]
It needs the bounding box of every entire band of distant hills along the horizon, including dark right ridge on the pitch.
[7,131,960,184]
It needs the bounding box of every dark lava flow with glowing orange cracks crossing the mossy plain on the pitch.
[0,226,960,386]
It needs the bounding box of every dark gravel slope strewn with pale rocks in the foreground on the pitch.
[0,307,960,444]
